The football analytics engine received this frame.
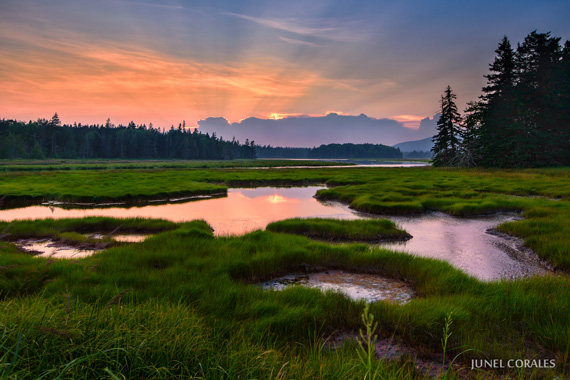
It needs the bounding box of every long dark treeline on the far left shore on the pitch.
[0,113,256,160]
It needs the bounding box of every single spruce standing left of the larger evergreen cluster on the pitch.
[431,86,462,166]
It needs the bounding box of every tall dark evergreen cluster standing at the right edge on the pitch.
[432,31,570,168]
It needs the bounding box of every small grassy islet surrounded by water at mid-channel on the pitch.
[266,218,411,242]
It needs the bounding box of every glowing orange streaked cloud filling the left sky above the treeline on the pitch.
[0,25,338,126]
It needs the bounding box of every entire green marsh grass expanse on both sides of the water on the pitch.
[0,168,570,379]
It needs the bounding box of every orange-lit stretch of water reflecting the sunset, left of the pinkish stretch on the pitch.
[0,186,358,236]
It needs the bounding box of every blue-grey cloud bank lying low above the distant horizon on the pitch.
[198,113,437,148]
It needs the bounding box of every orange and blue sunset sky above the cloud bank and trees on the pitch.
[0,0,570,131]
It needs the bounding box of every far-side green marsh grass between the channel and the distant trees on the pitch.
[0,166,570,271]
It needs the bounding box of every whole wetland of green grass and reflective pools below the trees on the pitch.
[0,162,570,379]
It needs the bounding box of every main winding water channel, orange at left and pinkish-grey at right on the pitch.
[0,186,548,280]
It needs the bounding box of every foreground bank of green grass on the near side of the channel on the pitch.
[0,215,570,379]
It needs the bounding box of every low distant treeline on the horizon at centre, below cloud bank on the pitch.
[256,143,402,159]
